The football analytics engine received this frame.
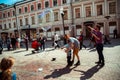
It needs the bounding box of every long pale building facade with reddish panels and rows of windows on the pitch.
[0,0,120,39]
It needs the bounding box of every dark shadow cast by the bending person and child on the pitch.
[44,66,76,79]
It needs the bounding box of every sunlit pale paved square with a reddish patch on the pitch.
[0,39,120,80]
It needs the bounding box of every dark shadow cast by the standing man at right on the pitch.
[74,65,103,80]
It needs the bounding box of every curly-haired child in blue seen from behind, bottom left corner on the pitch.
[0,57,17,80]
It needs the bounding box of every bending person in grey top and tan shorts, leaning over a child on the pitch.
[65,34,80,66]
